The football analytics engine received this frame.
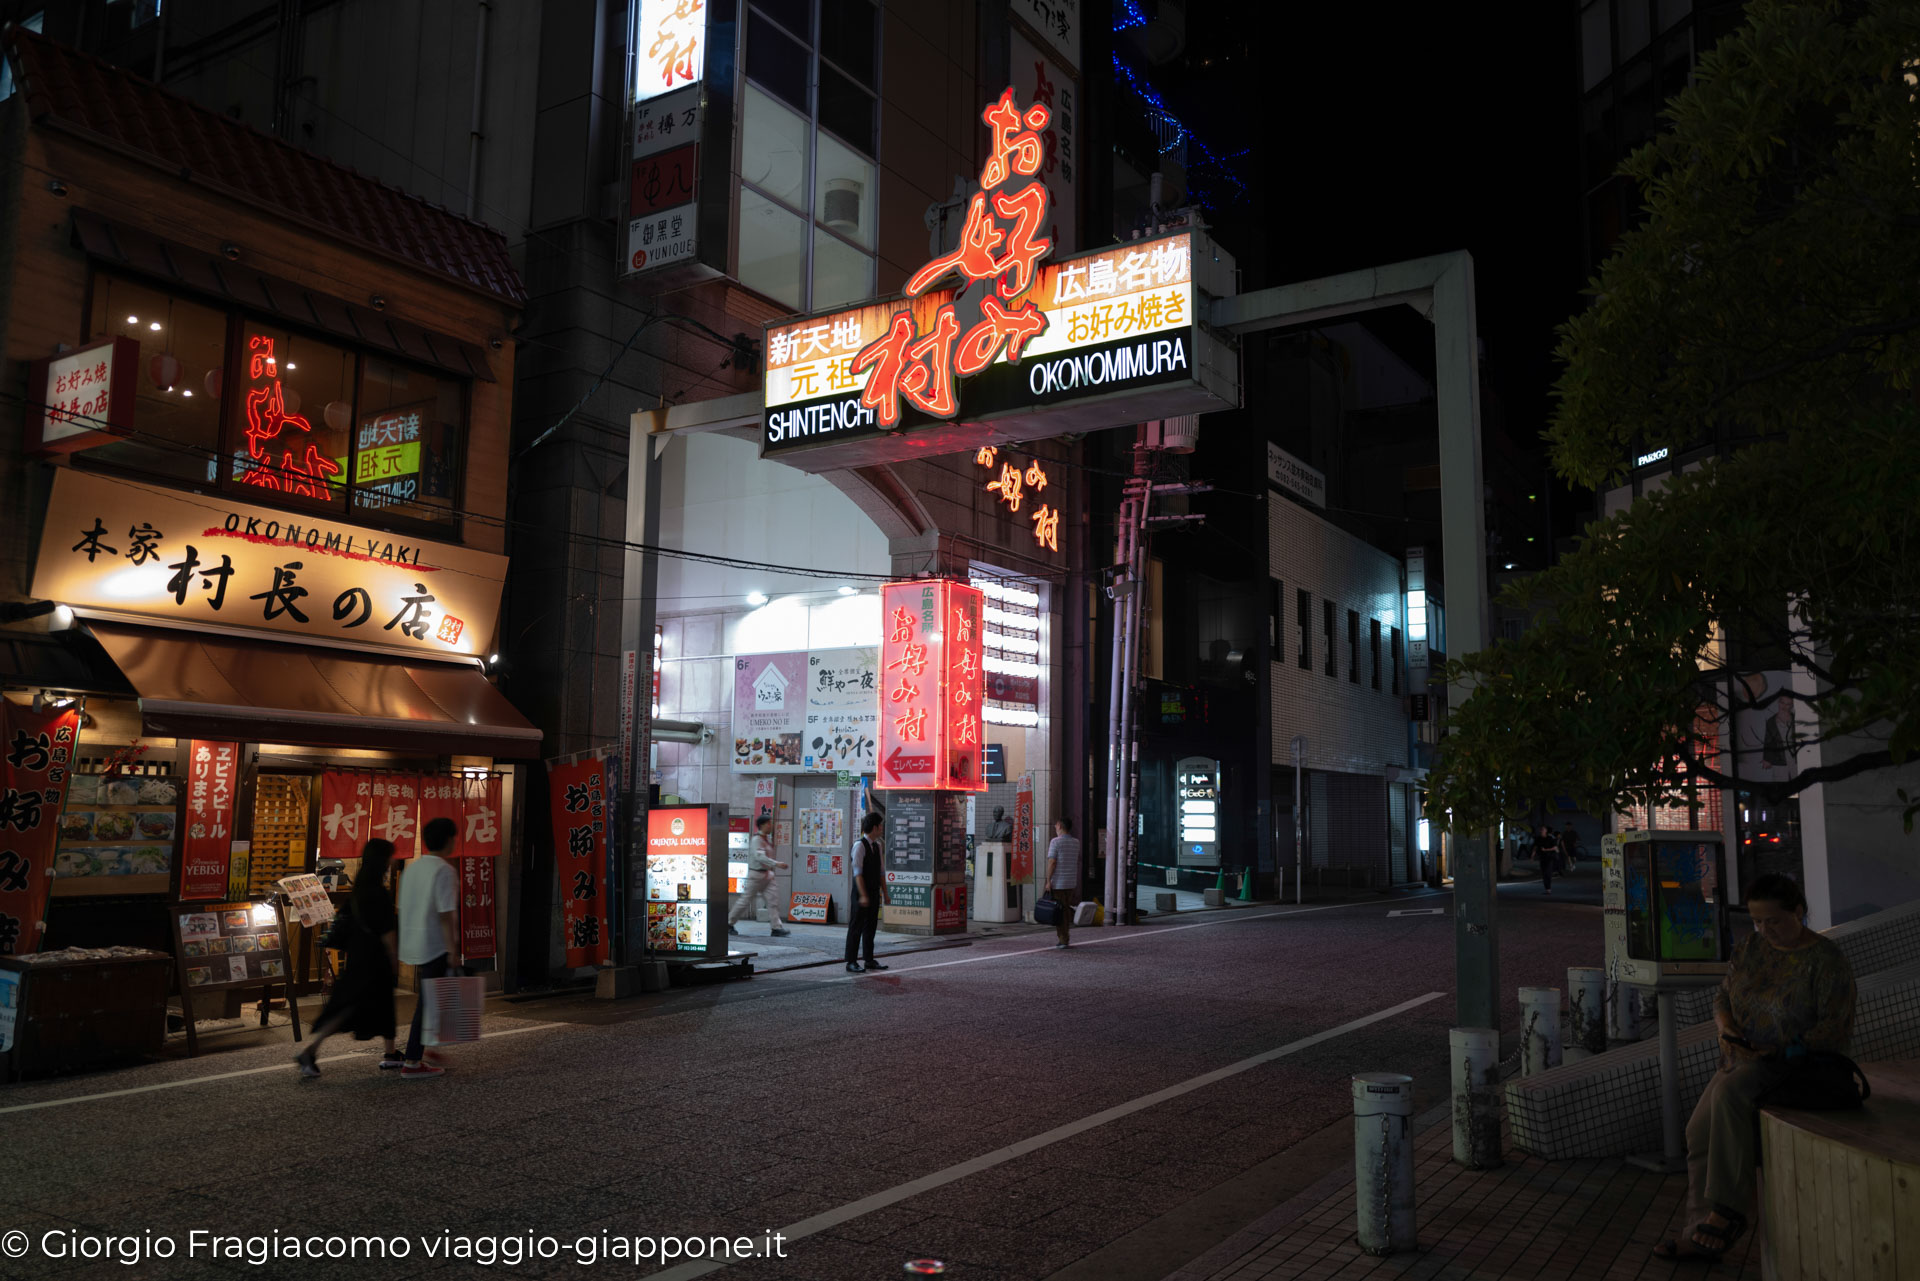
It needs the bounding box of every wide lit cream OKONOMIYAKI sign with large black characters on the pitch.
[33,467,507,659]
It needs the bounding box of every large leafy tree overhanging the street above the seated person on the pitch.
[1428,0,1920,830]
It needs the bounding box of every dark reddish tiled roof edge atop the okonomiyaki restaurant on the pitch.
[6,27,526,305]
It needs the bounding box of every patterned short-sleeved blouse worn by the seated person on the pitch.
[1713,933,1853,1054]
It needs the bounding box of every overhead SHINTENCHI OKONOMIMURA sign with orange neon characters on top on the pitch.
[760,90,1238,471]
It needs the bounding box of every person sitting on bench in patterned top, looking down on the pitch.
[1653,876,1853,1262]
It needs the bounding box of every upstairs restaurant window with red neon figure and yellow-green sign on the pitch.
[77,273,467,532]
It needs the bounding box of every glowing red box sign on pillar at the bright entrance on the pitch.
[876,578,987,791]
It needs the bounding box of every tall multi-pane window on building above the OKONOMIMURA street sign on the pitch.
[735,0,879,311]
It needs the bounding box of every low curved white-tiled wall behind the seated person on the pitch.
[1505,960,1920,1160]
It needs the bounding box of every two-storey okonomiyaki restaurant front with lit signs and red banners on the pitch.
[0,27,541,1060]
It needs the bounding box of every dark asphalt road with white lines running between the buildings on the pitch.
[0,870,1599,1281]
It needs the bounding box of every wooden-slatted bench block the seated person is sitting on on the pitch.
[1761,1060,1920,1281]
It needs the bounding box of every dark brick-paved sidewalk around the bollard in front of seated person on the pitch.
[1165,1108,1761,1281]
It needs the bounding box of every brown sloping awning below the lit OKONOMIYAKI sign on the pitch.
[86,622,541,759]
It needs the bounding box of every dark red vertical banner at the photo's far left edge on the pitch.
[0,699,81,956]
